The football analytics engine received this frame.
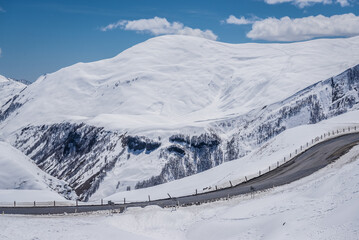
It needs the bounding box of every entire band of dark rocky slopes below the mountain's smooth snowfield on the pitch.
[6,65,359,200]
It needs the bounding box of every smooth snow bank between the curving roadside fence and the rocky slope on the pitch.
[99,111,359,202]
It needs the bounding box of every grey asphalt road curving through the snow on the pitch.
[0,133,359,215]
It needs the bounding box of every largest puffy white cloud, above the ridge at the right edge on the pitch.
[247,13,359,41]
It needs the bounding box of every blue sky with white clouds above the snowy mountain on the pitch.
[0,0,359,81]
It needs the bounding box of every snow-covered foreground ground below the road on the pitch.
[0,142,359,240]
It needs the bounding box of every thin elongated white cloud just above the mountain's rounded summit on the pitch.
[101,17,217,40]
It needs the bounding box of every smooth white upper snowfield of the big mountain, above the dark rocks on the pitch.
[3,36,359,134]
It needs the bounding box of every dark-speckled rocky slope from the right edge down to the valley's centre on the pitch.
[136,65,359,188]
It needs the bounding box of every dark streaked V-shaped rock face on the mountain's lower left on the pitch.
[11,123,160,200]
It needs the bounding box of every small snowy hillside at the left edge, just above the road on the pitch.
[0,141,71,202]
